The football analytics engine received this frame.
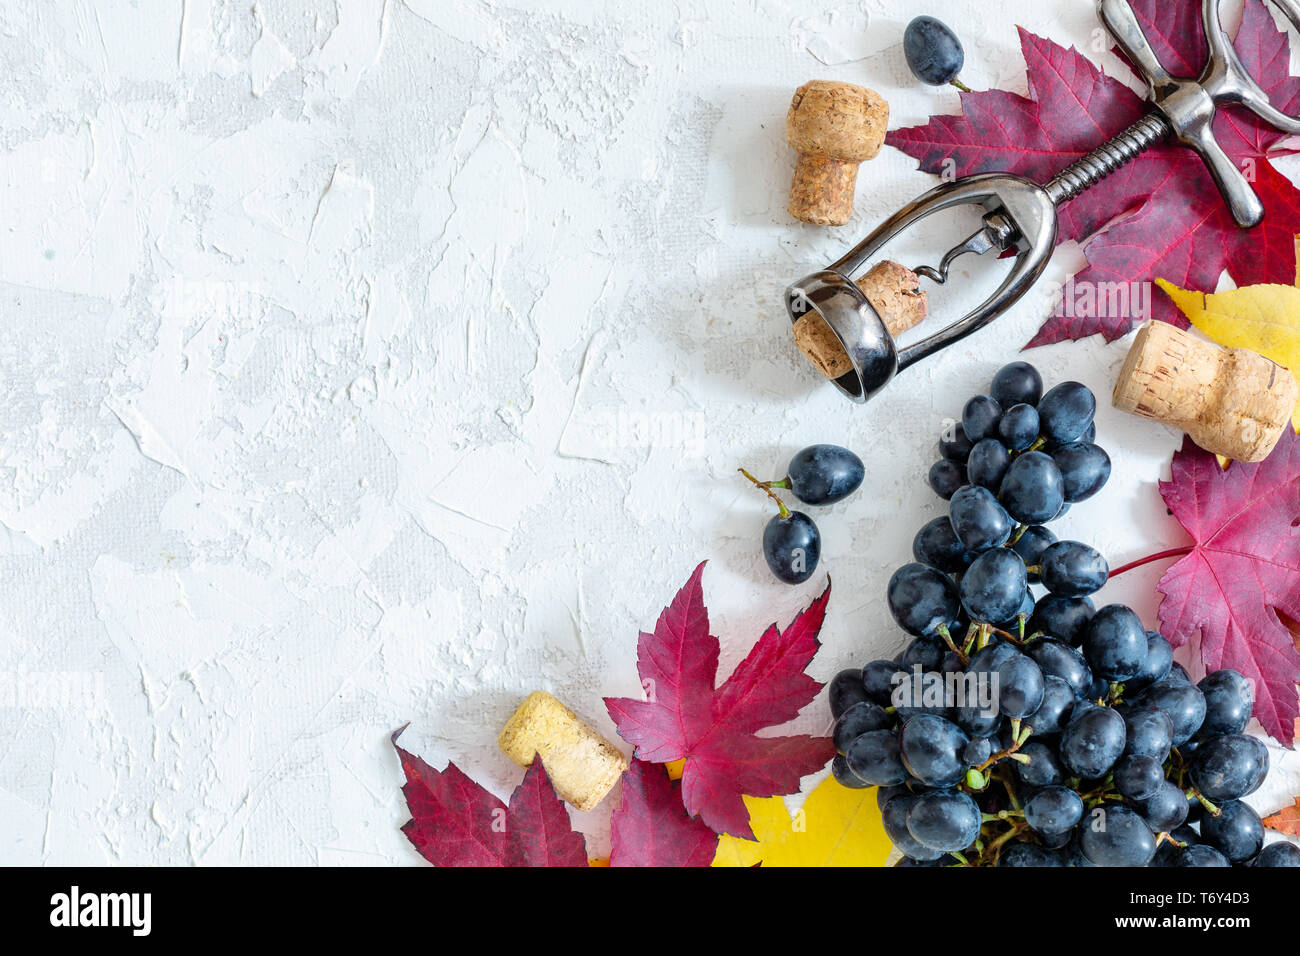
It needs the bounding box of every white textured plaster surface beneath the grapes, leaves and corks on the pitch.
[0,0,1300,864]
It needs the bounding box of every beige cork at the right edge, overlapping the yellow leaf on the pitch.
[1112,321,1297,462]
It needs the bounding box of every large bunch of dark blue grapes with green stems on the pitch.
[831,362,1300,866]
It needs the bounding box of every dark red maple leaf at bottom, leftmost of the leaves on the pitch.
[393,727,588,866]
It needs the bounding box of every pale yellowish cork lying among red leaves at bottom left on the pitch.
[497,691,628,810]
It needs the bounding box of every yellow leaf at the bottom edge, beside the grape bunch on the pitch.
[714,777,892,866]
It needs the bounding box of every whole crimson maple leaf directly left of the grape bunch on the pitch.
[605,564,835,839]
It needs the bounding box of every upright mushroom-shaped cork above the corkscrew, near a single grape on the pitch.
[785,79,889,226]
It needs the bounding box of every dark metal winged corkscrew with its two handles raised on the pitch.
[785,0,1300,402]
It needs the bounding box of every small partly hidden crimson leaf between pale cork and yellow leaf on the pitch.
[610,760,718,866]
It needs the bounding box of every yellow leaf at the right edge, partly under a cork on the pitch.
[1156,242,1300,432]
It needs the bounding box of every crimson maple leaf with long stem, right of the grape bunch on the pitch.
[1156,428,1300,747]
